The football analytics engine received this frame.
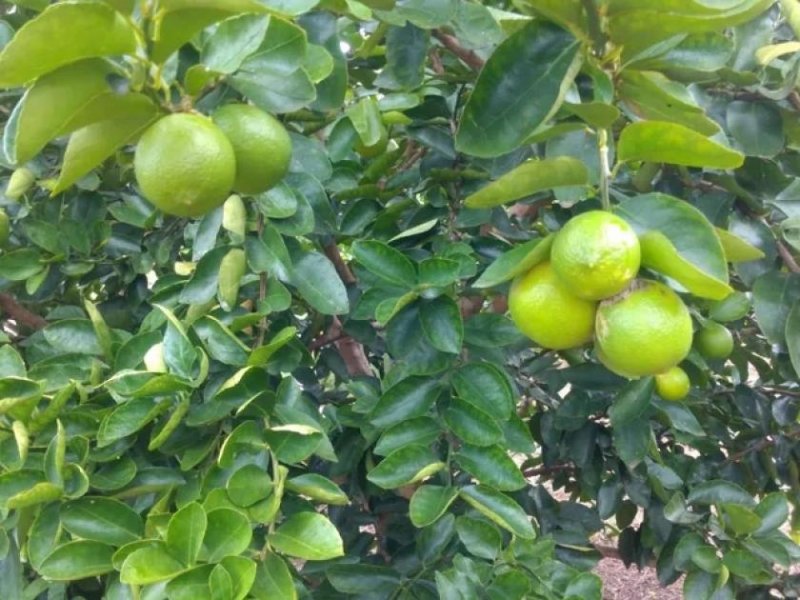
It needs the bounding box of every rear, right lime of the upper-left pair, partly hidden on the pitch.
[212,104,292,194]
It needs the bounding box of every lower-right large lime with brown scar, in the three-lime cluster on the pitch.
[595,280,692,377]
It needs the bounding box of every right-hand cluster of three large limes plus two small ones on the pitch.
[508,211,733,400]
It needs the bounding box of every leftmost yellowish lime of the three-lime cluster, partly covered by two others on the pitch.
[508,263,597,350]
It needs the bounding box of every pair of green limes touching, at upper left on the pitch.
[134,104,292,217]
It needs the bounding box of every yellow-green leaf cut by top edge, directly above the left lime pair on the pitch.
[151,0,268,63]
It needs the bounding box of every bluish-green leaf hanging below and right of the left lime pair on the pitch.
[290,252,350,315]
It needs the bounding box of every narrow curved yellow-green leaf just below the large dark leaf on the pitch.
[464,156,589,208]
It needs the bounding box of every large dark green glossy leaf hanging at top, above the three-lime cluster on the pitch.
[456,21,582,158]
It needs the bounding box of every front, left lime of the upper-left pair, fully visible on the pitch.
[133,113,236,217]
